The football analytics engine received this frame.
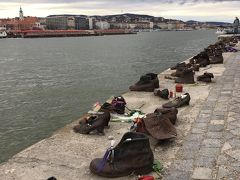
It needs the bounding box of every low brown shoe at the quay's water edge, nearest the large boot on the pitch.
[73,111,110,134]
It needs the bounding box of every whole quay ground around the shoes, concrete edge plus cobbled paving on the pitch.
[0,44,240,180]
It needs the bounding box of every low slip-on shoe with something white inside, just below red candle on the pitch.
[162,93,191,108]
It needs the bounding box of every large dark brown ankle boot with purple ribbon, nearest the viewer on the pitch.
[89,132,154,178]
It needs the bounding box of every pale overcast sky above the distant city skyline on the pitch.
[0,0,240,22]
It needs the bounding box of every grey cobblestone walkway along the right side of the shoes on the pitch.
[164,53,240,180]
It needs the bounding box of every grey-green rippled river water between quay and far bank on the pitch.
[0,30,217,163]
